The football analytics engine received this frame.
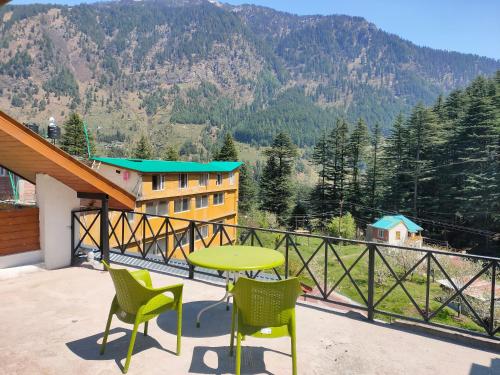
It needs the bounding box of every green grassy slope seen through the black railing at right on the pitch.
[236,225,490,333]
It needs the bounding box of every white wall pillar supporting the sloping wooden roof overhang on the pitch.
[36,174,80,269]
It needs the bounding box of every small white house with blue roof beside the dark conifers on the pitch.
[366,215,423,247]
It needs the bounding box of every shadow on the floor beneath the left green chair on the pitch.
[66,327,175,370]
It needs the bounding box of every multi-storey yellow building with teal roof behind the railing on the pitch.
[87,158,241,256]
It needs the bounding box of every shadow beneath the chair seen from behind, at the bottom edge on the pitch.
[189,345,290,375]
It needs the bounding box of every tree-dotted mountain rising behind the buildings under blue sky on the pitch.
[0,0,500,146]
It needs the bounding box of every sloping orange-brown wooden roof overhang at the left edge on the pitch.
[0,111,135,209]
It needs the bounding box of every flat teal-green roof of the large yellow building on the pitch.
[93,158,243,173]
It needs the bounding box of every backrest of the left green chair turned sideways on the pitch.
[103,262,151,314]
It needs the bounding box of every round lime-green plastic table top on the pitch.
[188,245,285,271]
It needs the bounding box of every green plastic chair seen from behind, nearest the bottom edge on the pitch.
[229,278,302,375]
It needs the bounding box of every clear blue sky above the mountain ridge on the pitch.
[7,0,500,59]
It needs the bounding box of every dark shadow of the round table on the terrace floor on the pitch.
[156,301,233,338]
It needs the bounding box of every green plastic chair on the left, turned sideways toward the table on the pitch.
[101,262,183,374]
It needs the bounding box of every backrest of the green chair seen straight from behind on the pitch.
[232,277,302,327]
